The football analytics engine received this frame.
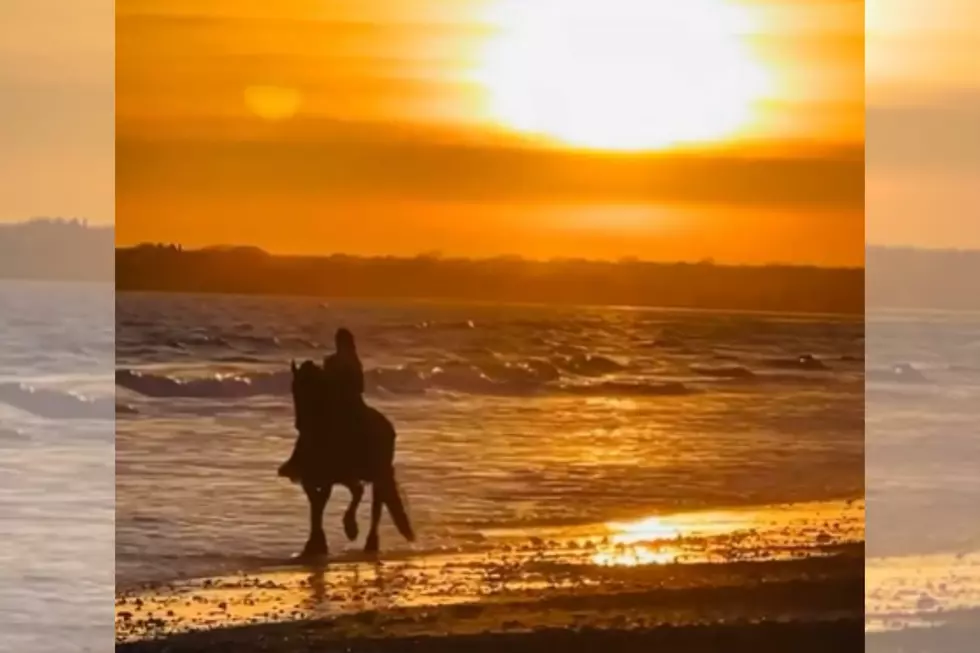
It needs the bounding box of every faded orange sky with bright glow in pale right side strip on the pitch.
[866,0,980,249]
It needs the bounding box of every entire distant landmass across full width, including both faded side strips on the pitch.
[9,218,980,314]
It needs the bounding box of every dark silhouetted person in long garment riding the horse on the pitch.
[279,328,366,481]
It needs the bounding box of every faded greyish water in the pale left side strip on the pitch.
[0,280,115,653]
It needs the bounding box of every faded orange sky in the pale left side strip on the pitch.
[0,0,115,223]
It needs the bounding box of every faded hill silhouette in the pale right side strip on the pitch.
[866,246,980,311]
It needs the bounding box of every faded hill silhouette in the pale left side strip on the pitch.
[0,218,115,282]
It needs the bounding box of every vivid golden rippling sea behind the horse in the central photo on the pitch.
[115,293,865,589]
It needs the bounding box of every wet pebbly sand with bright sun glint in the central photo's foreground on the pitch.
[116,502,864,652]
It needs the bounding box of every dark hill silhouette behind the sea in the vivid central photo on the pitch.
[116,244,864,314]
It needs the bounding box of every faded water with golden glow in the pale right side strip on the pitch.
[865,310,980,636]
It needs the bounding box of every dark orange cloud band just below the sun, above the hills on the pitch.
[117,121,864,210]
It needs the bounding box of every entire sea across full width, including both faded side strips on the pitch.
[0,281,980,652]
